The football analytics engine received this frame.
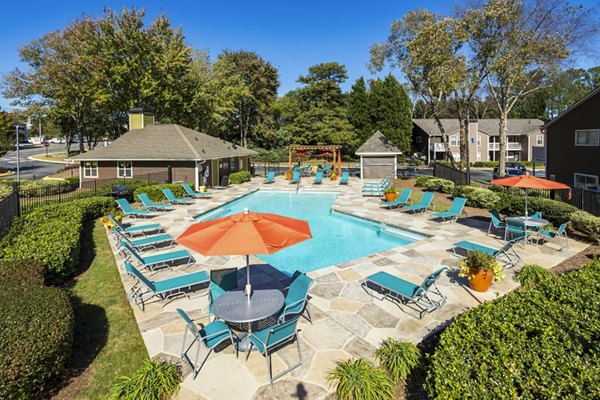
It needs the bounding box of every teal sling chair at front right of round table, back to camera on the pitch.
[246,317,302,386]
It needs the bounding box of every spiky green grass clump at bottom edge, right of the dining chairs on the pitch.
[327,358,394,400]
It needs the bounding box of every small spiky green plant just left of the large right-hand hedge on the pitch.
[375,338,421,382]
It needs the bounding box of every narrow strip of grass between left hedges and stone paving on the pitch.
[55,220,148,399]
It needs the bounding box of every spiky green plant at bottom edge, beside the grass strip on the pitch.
[108,360,181,400]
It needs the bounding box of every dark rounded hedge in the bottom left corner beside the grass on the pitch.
[0,261,73,399]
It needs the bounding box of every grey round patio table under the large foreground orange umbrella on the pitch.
[213,289,283,351]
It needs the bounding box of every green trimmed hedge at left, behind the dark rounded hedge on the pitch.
[0,197,114,284]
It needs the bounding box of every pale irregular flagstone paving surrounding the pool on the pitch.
[105,176,586,400]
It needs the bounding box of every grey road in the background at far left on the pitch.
[0,144,70,179]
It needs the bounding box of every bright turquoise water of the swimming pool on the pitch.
[197,191,424,274]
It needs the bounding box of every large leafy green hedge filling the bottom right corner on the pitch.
[426,260,600,399]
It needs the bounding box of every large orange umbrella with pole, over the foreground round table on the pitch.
[176,208,312,295]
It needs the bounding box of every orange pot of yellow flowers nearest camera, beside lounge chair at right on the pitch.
[458,251,504,292]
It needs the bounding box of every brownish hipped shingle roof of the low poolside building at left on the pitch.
[69,124,257,161]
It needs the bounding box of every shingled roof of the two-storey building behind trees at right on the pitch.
[413,119,544,136]
